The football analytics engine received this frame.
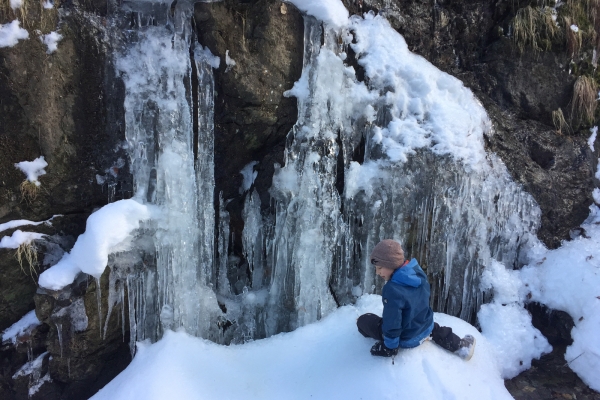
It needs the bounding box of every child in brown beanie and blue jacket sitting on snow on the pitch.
[356,239,475,360]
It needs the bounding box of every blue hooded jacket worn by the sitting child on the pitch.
[381,258,433,349]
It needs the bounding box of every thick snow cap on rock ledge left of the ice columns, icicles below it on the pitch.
[38,199,151,290]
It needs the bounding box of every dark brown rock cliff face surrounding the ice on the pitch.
[0,0,599,399]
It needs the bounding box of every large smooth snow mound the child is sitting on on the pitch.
[93,295,512,400]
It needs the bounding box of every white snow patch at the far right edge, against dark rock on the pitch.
[520,205,600,391]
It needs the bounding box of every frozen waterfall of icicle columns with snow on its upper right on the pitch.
[103,2,540,343]
